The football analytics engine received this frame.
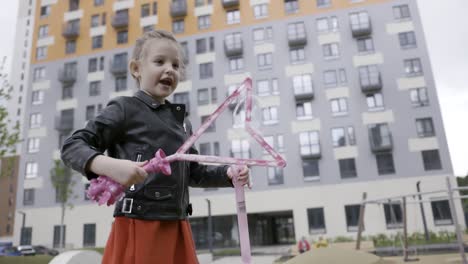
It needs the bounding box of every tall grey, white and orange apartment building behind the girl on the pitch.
[15,0,464,248]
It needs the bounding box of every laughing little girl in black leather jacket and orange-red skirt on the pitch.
[62,30,249,264]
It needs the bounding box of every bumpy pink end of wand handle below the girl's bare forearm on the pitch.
[87,176,124,206]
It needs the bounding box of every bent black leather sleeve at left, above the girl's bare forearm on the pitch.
[61,98,125,180]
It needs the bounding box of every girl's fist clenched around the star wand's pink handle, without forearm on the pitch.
[106,159,148,187]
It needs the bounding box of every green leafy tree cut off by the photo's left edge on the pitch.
[0,57,20,177]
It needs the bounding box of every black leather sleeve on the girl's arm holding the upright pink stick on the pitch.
[186,120,233,188]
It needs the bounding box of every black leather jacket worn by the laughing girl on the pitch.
[61,91,232,220]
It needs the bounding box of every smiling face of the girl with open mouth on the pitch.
[131,39,180,103]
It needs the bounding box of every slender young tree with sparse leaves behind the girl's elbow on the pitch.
[50,160,75,248]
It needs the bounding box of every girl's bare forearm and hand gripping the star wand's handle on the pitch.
[89,155,148,187]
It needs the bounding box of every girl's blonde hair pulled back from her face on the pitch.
[131,29,186,82]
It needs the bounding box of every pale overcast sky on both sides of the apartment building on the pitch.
[0,0,468,176]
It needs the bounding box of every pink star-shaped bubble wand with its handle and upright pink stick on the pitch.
[88,78,286,264]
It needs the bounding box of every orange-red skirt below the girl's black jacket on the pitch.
[102,217,198,264]
